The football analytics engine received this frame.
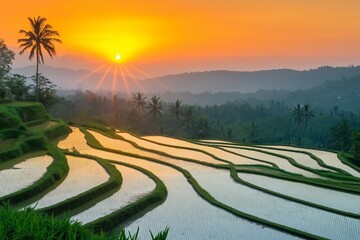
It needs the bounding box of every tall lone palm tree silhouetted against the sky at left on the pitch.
[18,16,61,101]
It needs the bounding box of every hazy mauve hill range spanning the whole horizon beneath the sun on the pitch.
[13,65,360,93]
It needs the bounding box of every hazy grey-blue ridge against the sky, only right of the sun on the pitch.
[142,66,360,93]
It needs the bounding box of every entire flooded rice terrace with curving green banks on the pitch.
[0,102,360,239]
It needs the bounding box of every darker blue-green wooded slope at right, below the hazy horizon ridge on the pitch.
[161,75,360,111]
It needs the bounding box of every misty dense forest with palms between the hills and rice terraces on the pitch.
[47,86,360,159]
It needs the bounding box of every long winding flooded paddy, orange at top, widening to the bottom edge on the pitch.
[59,128,293,240]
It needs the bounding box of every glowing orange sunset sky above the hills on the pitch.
[0,0,360,75]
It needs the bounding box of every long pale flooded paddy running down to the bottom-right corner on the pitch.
[169,158,360,239]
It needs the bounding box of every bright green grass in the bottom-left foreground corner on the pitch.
[0,206,168,240]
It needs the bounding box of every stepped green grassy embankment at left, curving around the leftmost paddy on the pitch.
[0,102,70,207]
